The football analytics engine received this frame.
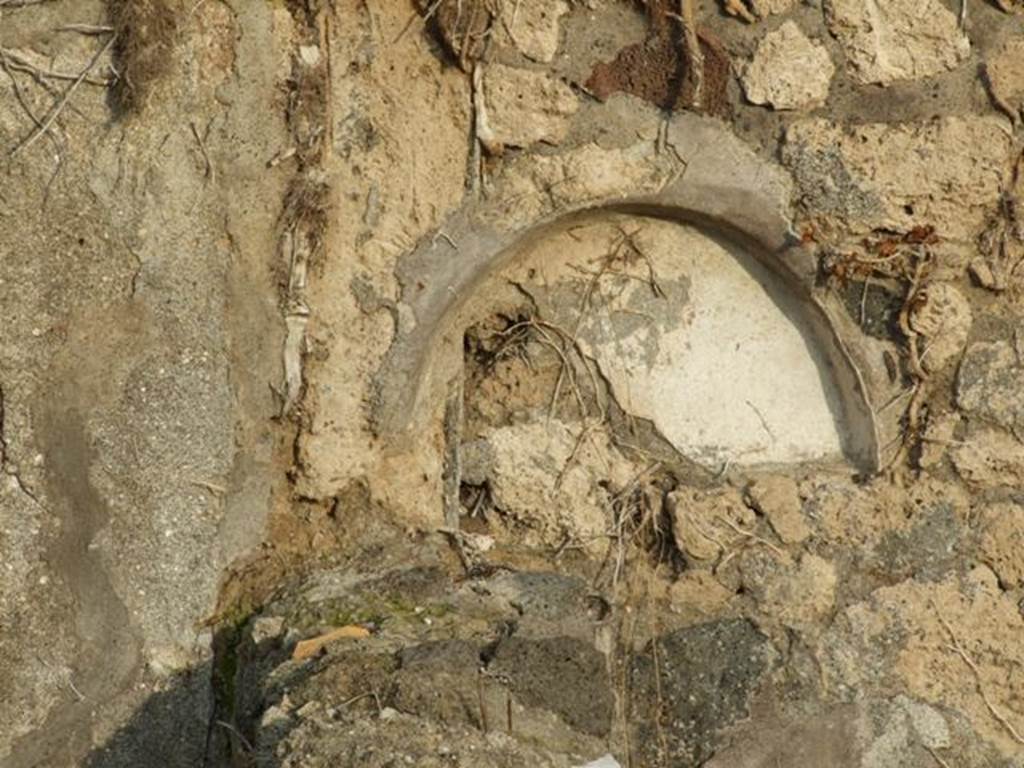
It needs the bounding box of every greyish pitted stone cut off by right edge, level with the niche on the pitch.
[956,341,1024,431]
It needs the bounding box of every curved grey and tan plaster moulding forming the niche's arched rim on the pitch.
[374,114,882,472]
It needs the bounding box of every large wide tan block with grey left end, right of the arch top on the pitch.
[782,117,1010,241]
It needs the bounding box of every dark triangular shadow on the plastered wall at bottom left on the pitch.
[84,664,218,768]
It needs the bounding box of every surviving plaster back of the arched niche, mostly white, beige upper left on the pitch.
[522,219,843,468]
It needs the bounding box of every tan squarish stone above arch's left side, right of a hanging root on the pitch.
[477,63,579,151]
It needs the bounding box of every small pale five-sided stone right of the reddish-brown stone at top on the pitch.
[742,22,836,110]
